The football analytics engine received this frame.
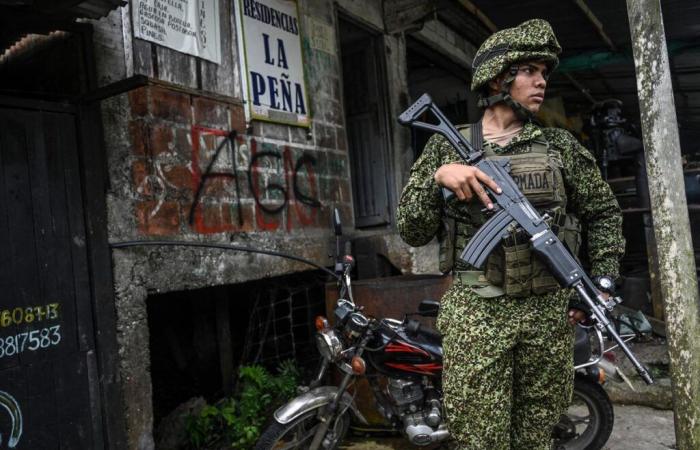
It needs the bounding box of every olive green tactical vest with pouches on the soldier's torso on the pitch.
[438,125,581,297]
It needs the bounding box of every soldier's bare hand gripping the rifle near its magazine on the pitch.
[435,163,501,209]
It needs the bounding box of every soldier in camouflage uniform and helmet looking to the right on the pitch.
[397,19,624,450]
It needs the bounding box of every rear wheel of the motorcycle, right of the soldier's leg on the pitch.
[554,377,615,450]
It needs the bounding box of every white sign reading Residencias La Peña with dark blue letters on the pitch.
[235,0,310,126]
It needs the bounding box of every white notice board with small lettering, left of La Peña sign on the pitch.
[131,0,221,64]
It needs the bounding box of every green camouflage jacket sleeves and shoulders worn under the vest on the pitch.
[397,123,625,277]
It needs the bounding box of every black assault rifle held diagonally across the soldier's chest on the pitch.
[399,94,654,384]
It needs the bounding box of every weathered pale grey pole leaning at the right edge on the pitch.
[627,0,700,450]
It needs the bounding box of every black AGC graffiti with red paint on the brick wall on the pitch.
[189,126,321,233]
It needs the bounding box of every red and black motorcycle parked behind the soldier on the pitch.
[255,211,617,450]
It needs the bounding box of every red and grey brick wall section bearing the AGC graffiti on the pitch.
[123,85,351,237]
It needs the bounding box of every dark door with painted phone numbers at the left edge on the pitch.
[0,106,103,450]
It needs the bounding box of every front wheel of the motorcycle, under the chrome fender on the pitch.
[255,407,350,450]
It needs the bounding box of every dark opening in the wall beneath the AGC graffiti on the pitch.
[147,271,327,428]
